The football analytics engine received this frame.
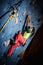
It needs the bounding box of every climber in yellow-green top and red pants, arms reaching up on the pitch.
[2,15,34,56]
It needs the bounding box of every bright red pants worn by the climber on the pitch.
[7,32,26,56]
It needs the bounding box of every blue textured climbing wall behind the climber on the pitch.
[0,0,42,65]
